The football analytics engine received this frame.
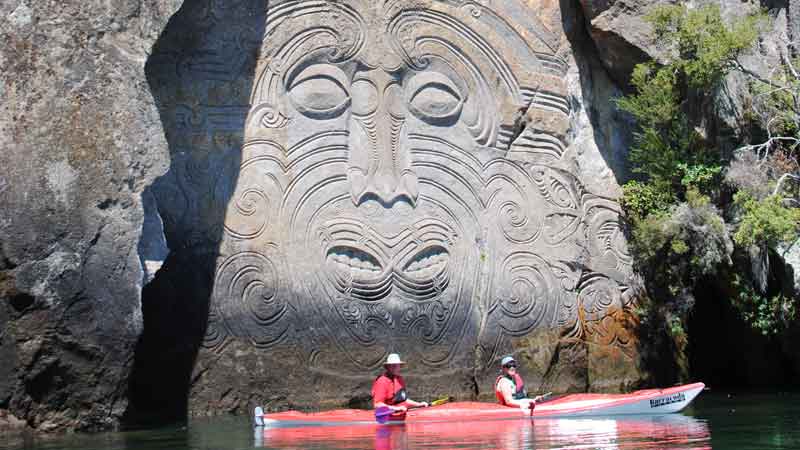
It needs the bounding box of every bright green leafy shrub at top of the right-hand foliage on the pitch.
[617,5,764,203]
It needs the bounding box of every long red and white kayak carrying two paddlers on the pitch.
[256,383,705,426]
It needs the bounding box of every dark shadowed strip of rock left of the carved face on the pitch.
[125,0,267,427]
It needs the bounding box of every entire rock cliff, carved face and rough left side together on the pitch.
[0,0,798,430]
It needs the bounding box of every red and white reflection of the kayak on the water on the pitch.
[255,414,711,450]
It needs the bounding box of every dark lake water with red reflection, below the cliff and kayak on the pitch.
[0,392,800,450]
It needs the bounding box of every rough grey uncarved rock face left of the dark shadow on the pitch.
[0,0,179,430]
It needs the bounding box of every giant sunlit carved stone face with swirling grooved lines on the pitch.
[208,0,624,370]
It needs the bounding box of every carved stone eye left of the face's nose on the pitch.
[289,64,350,119]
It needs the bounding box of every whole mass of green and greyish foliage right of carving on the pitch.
[617,5,800,342]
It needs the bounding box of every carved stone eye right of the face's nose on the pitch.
[407,72,464,126]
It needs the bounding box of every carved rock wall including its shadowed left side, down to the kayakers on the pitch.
[134,0,644,414]
